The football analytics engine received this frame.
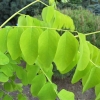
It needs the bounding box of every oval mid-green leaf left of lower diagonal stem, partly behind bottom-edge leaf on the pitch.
[31,74,46,96]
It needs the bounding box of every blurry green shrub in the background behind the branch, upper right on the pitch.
[62,8,100,47]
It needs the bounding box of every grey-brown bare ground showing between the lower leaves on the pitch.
[0,77,95,100]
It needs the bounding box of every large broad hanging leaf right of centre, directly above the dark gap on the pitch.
[54,32,78,73]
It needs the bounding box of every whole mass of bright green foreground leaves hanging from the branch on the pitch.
[0,1,100,100]
